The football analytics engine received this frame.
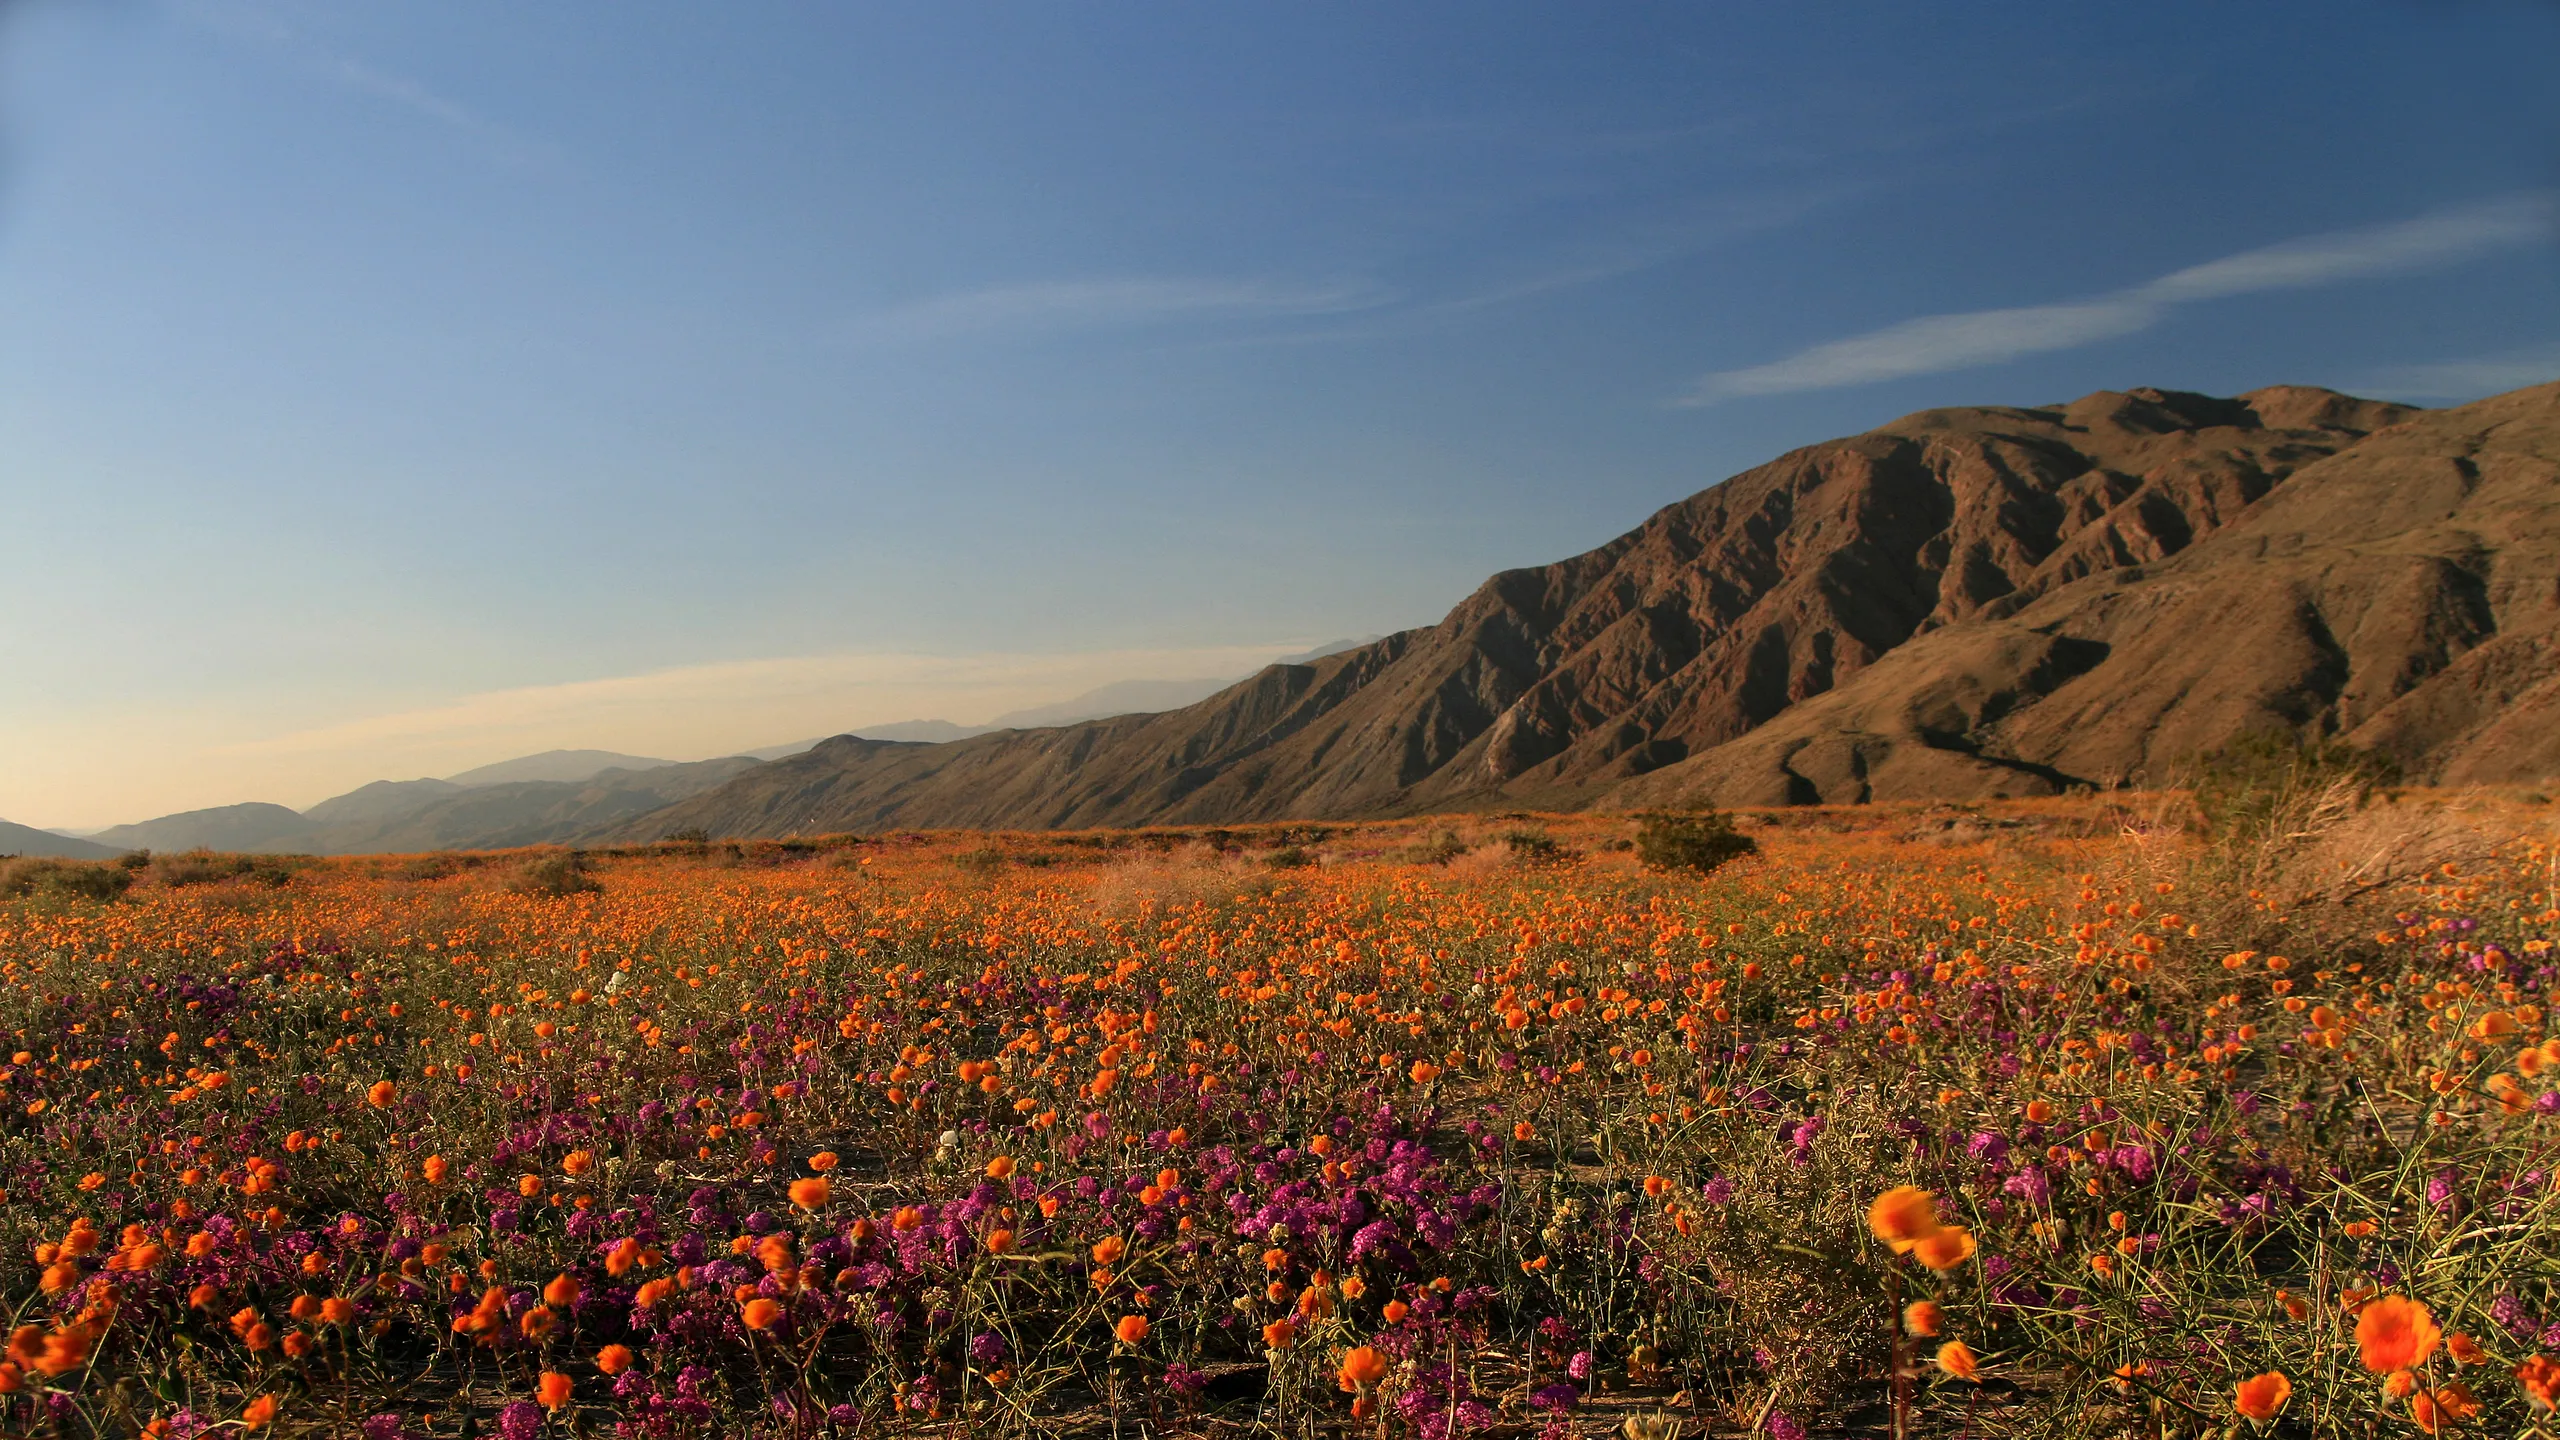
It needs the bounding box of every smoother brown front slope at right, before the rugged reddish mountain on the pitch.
[1613,384,2560,805]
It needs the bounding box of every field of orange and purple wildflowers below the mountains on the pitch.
[0,797,2560,1440]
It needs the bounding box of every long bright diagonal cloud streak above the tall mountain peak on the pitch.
[1679,192,2555,405]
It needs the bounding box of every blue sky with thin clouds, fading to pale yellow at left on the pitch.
[0,0,2560,825]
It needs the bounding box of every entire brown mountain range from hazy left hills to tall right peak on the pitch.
[24,384,2560,853]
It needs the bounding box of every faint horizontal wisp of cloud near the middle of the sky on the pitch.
[855,277,1390,341]
